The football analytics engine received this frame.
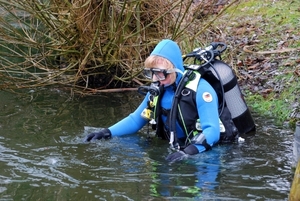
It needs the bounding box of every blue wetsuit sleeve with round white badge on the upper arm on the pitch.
[195,79,220,152]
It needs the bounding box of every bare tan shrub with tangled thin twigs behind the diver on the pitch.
[0,0,238,93]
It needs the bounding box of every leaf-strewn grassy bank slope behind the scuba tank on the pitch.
[214,0,300,127]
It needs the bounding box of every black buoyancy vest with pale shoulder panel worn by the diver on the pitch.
[153,71,238,147]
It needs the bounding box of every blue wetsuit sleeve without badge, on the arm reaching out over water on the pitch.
[108,94,149,136]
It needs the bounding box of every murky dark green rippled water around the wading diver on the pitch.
[0,90,293,201]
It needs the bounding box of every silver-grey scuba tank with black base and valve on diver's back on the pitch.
[183,42,255,134]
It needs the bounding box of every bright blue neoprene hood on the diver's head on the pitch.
[151,39,184,84]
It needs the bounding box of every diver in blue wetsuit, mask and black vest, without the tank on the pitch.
[85,39,254,162]
